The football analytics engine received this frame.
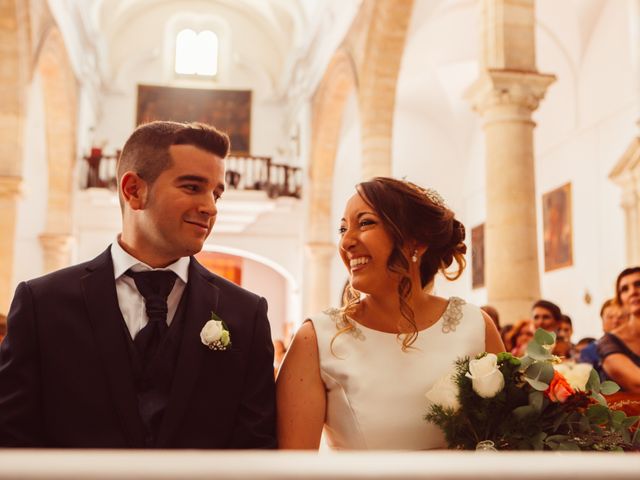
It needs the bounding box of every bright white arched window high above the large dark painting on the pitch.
[175,28,218,77]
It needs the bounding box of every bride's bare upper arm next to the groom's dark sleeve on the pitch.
[276,321,327,450]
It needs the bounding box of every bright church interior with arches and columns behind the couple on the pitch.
[0,0,640,352]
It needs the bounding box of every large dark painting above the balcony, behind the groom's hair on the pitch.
[136,85,251,156]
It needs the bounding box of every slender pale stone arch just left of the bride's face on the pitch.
[305,48,357,312]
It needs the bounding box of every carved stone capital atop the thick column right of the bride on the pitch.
[465,69,556,116]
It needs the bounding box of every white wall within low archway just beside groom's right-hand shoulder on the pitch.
[242,258,287,339]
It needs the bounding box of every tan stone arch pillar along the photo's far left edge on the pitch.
[0,0,30,313]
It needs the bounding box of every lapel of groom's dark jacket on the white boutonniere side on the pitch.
[157,258,219,448]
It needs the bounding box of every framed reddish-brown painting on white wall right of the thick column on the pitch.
[542,183,573,272]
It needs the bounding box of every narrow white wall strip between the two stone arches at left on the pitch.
[13,71,49,286]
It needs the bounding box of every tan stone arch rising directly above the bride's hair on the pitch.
[358,0,413,179]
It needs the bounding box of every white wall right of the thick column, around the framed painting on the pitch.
[536,1,638,340]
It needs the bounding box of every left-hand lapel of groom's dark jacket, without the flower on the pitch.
[82,248,144,447]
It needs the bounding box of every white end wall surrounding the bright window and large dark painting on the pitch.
[95,2,286,156]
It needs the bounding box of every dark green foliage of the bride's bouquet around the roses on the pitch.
[425,329,640,451]
